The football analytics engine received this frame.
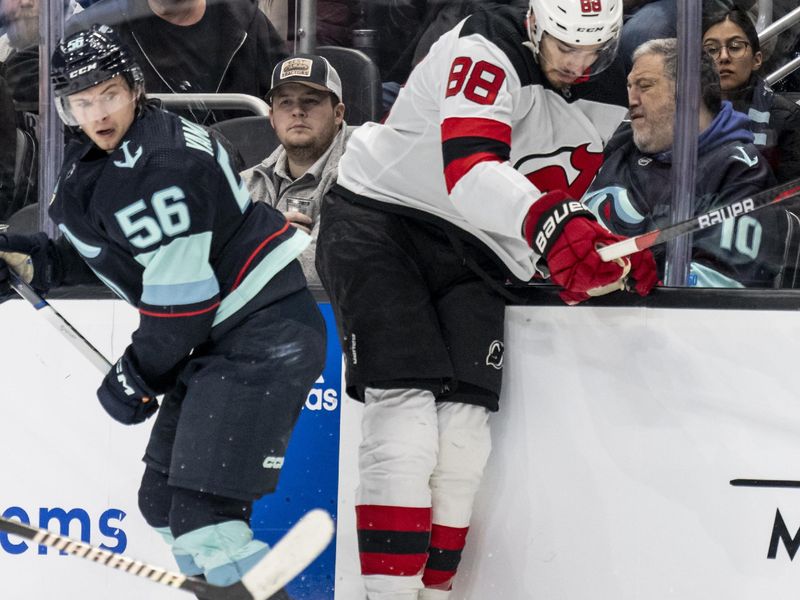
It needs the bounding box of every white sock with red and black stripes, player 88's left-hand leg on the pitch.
[356,388,438,600]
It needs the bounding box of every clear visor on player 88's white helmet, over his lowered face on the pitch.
[539,31,619,85]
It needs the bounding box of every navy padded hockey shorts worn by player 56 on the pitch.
[144,289,325,501]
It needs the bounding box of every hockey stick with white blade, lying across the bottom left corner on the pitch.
[0,508,334,600]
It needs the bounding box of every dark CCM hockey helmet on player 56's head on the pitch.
[50,25,144,125]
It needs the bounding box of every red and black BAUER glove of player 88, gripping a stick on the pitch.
[525,190,658,304]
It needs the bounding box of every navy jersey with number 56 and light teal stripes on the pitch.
[50,105,310,380]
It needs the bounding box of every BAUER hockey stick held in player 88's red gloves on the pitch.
[597,179,800,261]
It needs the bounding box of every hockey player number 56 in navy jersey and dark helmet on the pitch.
[0,25,325,597]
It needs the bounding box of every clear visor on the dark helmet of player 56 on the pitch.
[55,77,138,127]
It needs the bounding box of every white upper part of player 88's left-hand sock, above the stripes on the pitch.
[357,388,438,506]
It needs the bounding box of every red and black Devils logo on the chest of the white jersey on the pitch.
[514,144,603,199]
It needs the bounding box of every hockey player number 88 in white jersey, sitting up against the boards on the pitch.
[317,0,656,600]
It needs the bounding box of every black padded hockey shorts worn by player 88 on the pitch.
[316,188,505,410]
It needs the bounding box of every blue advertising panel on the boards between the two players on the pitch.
[251,303,342,600]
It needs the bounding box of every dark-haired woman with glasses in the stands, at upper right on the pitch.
[703,9,800,182]
